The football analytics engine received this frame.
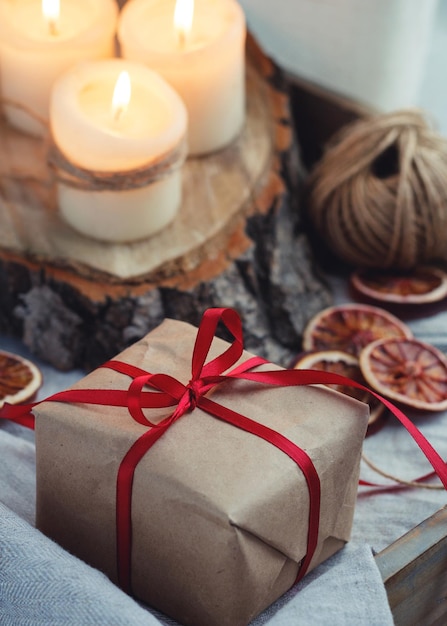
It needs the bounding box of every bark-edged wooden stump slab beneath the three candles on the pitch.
[0,36,330,370]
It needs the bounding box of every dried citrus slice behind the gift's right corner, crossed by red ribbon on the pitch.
[293,350,385,425]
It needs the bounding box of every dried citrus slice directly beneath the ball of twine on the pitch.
[351,267,447,304]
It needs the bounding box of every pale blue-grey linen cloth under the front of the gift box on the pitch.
[0,494,392,626]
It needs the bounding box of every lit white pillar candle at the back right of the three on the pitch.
[118,0,246,155]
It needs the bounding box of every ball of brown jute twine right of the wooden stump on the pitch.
[307,110,447,269]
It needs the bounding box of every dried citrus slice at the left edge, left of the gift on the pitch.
[0,350,42,408]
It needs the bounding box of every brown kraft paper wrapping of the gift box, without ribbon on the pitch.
[35,320,368,626]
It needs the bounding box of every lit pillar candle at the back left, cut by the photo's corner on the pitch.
[0,0,118,136]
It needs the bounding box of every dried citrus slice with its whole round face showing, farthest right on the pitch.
[360,338,447,411]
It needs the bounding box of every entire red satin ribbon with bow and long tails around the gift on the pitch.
[0,308,447,591]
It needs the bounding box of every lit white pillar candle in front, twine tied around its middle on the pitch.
[50,59,187,242]
